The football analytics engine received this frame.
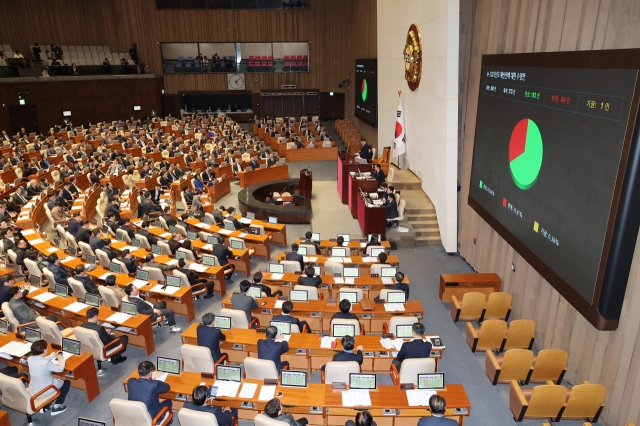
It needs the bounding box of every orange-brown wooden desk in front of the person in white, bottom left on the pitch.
[0,331,100,402]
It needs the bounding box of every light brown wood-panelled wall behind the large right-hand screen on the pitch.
[458,0,640,425]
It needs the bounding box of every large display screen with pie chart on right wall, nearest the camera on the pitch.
[469,56,638,330]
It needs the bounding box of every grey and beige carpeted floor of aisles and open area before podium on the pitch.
[8,156,592,426]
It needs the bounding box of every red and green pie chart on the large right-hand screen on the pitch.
[509,118,543,190]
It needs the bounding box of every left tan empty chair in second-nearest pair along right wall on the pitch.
[485,349,533,385]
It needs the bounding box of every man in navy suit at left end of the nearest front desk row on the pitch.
[127,361,171,419]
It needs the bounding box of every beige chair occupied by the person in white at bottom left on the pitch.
[0,374,60,426]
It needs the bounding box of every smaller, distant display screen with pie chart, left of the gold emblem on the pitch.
[355,59,378,127]
